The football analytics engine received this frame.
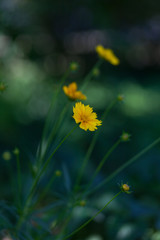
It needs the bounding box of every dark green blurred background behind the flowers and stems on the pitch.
[0,0,160,240]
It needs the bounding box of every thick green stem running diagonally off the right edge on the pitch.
[89,138,160,193]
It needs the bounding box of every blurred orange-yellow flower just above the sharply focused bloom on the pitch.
[63,82,86,100]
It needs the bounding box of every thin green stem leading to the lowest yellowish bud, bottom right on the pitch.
[62,191,122,240]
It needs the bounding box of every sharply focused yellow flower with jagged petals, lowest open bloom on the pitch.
[73,102,102,131]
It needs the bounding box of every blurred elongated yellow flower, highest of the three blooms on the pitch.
[96,45,120,65]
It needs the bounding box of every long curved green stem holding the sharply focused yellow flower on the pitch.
[17,125,78,230]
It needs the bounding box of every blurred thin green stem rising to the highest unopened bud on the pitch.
[38,69,70,159]
